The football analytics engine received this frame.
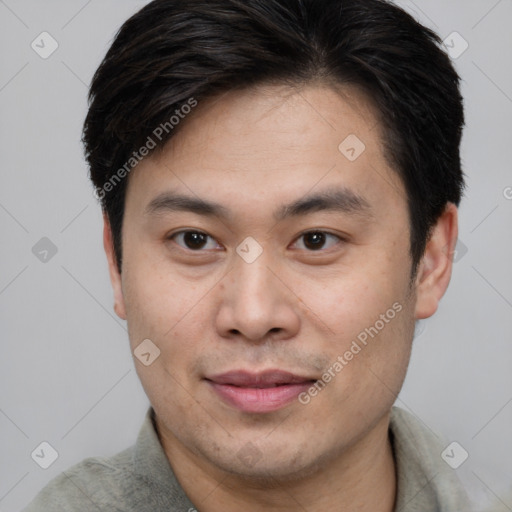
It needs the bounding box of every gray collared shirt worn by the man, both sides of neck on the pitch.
[23,407,470,512]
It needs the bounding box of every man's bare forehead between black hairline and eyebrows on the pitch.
[127,85,404,214]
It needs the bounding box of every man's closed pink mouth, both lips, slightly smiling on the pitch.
[205,370,316,413]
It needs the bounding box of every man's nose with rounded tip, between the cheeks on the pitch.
[216,256,300,343]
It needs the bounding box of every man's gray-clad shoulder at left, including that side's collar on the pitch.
[23,408,193,512]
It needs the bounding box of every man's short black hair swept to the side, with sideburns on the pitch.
[83,0,464,271]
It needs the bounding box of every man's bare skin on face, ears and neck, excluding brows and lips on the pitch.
[104,84,457,512]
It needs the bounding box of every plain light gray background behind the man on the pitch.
[0,0,512,512]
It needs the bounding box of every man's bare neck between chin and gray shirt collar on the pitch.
[157,415,396,512]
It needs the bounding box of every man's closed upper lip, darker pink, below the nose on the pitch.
[206,370,315,388]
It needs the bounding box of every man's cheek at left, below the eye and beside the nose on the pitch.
[124,260,218,380]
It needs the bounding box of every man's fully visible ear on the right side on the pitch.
[415,203,458,320]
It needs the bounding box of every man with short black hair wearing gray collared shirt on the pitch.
[26,0,469,512]
